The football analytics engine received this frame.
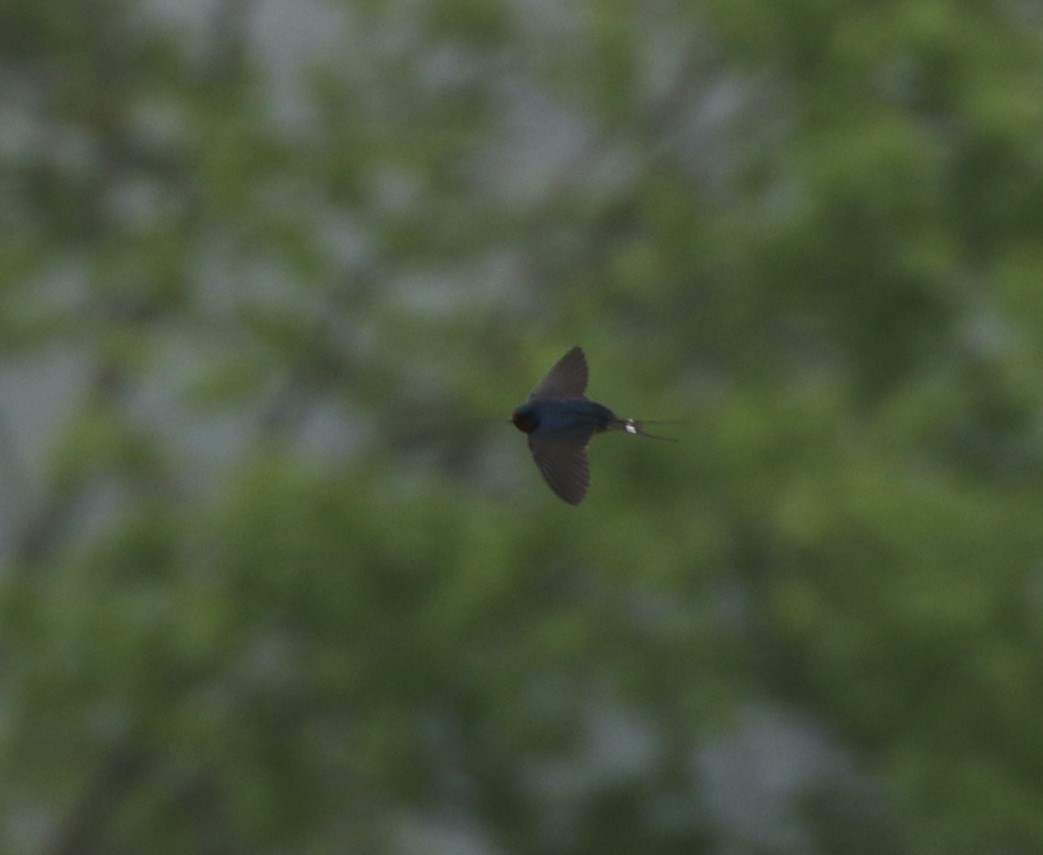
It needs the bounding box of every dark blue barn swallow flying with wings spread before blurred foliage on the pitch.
[511,347,661,505]
